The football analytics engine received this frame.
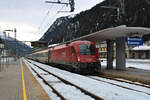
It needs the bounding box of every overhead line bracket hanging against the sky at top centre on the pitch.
[45,0,75,12]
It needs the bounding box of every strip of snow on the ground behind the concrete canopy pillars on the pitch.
[101,59,150,70]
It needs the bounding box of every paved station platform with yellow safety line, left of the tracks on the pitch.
[0,60,50,100]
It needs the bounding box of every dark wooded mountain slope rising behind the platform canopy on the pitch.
[40,0,150,44]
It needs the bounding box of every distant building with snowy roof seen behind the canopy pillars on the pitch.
[98,42,150,59]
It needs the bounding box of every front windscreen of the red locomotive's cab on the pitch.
[78,44,96,55]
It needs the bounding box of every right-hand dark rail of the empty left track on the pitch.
[28,61,104,100]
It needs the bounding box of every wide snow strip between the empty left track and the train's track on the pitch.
[25,61,150,100]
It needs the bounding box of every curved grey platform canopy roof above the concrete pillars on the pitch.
[75,25,150,42]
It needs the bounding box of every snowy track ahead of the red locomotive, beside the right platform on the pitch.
[87,76,150,95]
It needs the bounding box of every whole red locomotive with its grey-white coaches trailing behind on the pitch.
[28,41,101,74]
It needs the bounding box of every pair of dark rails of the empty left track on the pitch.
[27,60,104,100]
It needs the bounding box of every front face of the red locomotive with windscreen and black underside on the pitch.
[74,41,101,73]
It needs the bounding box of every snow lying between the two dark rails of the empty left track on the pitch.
[23,59,94,100]
